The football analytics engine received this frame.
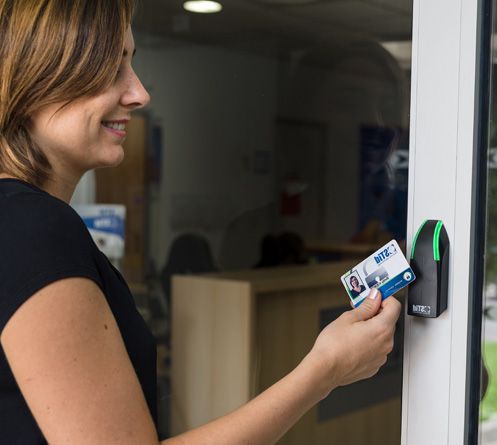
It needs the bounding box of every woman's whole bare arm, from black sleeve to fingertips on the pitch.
[0,278,400,445]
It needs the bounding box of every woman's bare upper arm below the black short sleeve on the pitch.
[0,278,158,445]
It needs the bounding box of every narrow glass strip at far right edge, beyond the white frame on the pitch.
[469,0,497,445]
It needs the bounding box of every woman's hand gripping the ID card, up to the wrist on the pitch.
[304,289,401,397]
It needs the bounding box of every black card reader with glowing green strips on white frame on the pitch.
[407,219,450,318]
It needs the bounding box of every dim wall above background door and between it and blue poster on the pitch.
[278,43,409,241]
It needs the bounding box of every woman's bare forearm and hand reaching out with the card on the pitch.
[162,288,400,445]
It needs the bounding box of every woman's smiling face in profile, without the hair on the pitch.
[30,29,150,180]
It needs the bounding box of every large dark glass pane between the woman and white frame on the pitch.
[75,0,412,445]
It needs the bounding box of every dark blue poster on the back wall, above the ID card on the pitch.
[359,125,409,240]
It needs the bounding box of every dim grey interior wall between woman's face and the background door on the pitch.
[134,36,277,267]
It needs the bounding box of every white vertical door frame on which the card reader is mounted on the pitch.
[402,0,484,445]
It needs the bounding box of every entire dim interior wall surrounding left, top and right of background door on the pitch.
[134,35,408,267]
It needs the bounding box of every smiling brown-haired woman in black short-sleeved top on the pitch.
[0,0,400,445]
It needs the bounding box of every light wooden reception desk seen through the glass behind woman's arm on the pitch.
[171,262,402,445]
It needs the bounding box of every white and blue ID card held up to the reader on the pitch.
[341,240,416,307]
